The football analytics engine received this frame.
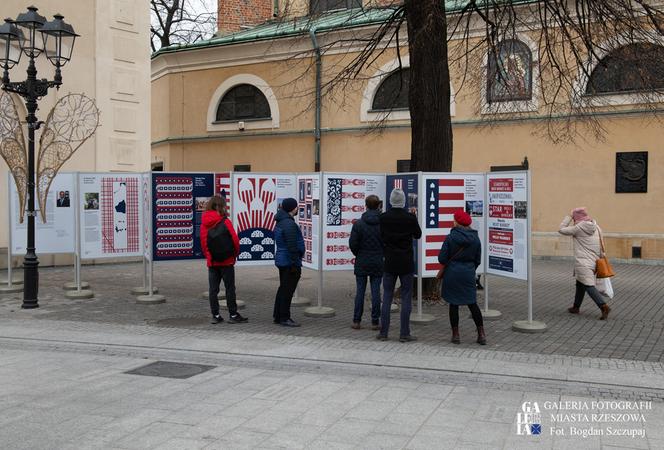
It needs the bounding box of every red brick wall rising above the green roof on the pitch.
[217,0,274,34]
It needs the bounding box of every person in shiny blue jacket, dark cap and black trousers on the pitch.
[273,198,304,327]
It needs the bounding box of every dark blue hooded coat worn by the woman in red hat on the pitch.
[438,227,482,305]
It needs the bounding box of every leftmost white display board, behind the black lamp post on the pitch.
[8,172,76,255]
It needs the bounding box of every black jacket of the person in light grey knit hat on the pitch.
[380,208,422,275]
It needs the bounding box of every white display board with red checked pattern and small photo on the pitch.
[78,173,144,259]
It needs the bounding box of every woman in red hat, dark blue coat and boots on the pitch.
[438,210,486,345]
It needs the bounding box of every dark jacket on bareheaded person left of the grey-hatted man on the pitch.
[348,209,383,277]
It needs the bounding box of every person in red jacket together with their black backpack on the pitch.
[201,195,247,323]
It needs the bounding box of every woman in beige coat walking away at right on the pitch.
[558,207,611,320]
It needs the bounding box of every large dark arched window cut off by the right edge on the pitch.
[586,43,664,95]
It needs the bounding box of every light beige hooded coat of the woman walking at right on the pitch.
[558,216,601,286]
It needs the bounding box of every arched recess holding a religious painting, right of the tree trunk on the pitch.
[486,39,533,103]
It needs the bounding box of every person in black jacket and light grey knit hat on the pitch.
[376,189,422,342]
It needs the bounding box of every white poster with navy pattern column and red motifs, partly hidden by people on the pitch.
[321,173,385,270]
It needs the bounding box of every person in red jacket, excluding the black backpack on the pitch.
[201,195,248,323]
